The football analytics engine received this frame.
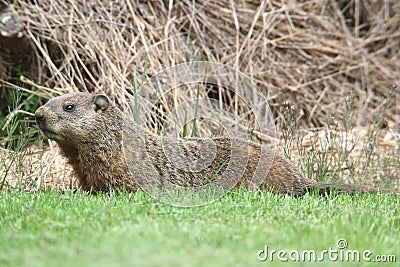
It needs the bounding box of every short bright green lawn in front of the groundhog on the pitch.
[0,190,400,266]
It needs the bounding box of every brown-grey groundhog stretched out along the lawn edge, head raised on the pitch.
[35,93,375,196]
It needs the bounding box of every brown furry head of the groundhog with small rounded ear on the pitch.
[35,93,115,145]
